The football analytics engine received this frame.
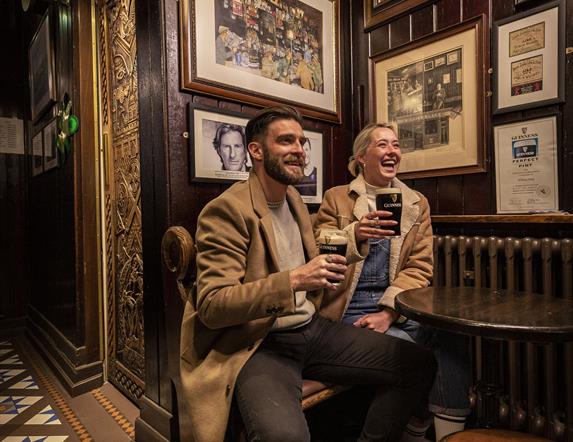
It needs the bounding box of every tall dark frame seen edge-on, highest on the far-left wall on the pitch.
[28,8,57,122]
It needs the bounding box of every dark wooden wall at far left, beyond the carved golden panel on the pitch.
[0,0,102,393]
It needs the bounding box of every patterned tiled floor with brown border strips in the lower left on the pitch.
[0,337,139,442]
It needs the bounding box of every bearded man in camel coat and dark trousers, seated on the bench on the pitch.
[181,107,435,442]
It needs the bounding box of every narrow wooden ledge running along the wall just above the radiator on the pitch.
[432,214,573,224]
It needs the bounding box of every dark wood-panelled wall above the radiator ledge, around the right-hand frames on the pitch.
[352,0,573,215]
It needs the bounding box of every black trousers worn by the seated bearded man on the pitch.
[235,316,436,442]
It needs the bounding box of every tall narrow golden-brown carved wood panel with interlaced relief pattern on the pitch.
[99,0,145,400]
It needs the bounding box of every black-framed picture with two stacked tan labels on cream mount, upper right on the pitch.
[493,0,565,114]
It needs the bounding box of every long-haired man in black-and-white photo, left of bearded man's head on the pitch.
[213,123,249,172]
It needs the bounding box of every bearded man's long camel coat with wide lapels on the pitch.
[180,172,320,442]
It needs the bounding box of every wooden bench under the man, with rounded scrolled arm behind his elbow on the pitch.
[161,226,349,420]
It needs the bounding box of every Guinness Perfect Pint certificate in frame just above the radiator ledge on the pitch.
[493,116,559,214]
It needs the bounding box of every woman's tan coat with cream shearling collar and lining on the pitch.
[315,175,433,321]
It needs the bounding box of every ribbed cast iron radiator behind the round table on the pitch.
[433,236,573,442]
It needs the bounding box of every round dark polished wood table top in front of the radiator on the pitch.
[396,287,573,342]
